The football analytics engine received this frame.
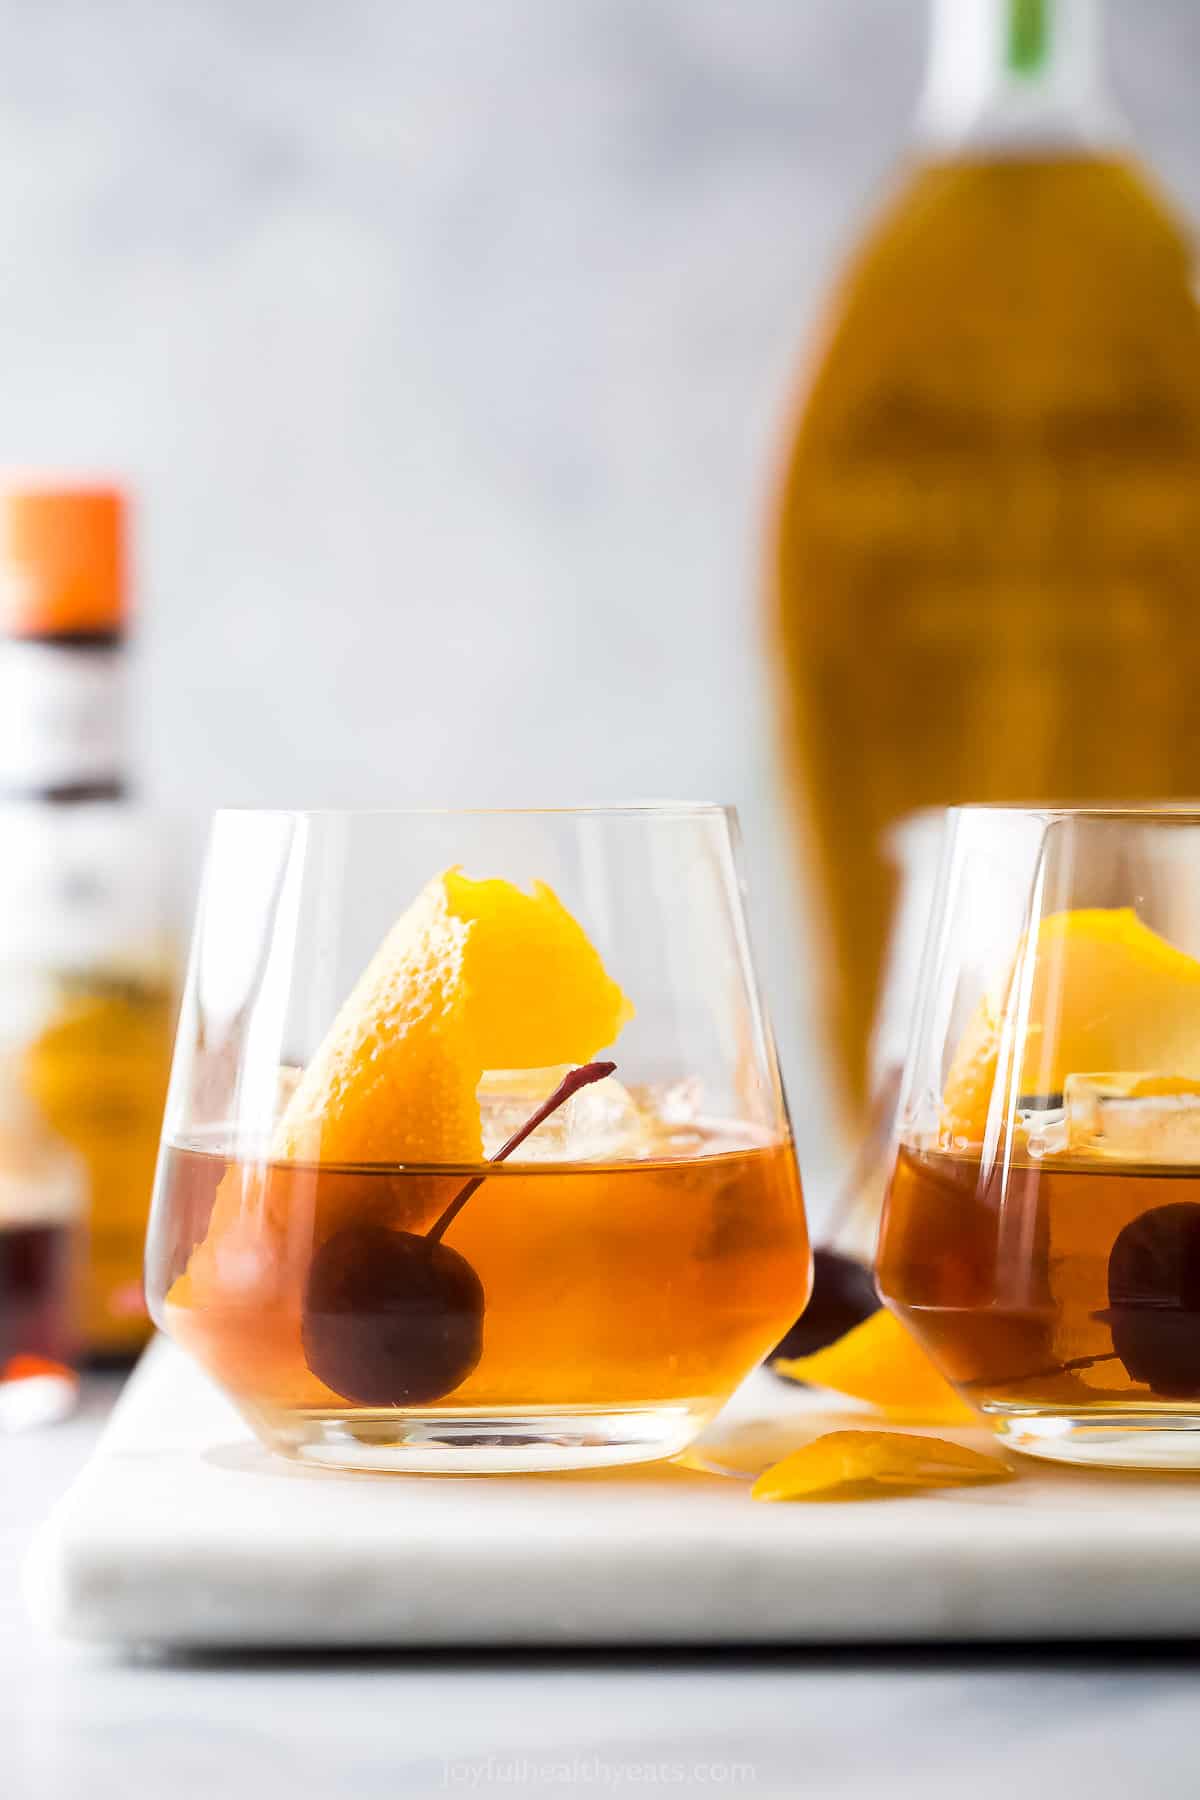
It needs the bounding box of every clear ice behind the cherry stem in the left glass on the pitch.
[477,1064,649,1163]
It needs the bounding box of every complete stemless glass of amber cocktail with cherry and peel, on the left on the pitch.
[146,806,811,1472]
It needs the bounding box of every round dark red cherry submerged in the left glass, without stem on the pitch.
[300,1226,484,1406]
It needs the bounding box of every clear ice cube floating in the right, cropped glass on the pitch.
[1063,1069,1200,1163]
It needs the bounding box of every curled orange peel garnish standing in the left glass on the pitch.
[167,868,633,1305]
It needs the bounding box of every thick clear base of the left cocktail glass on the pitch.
[250,1400,720,1474]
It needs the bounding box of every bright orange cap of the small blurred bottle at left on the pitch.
[0,481,128,637]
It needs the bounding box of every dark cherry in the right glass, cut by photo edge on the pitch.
[1097,1201,1200,1400]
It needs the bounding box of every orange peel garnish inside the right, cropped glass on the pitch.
[943,907,1200,1143]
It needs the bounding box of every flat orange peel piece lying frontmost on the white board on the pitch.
[750,1431,1015,1499]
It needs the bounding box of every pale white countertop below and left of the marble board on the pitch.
[0,1379,1200,1800]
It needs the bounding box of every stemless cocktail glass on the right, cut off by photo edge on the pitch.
[878,806,1200,1469]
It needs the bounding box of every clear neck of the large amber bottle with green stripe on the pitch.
[918,0,1121,155]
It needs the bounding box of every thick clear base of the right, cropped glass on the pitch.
[984,1406,1200,1474]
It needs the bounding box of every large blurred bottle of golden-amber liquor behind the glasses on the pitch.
[772,0,1200,1121]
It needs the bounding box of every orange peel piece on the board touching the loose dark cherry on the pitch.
[772,1307,979,1426]
